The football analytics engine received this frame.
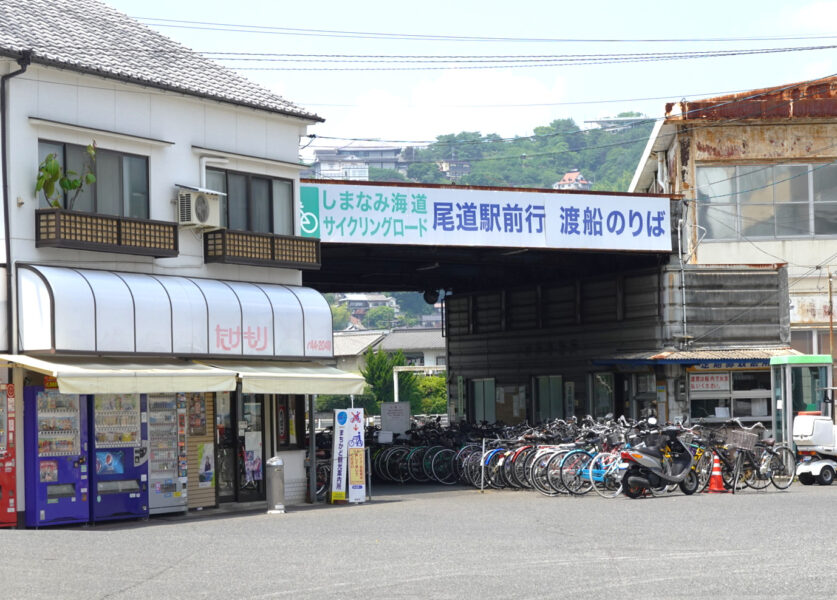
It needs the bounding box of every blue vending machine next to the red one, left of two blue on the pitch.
[23,386,90,527]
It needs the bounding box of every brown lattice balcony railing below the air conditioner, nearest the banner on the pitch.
[203,229,320,269]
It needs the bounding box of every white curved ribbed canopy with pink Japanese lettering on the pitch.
[17,265,333,360]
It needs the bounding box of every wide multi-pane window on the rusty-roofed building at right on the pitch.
[697,163,837,240]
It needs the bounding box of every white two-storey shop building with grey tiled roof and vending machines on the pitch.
[0,0,363,527]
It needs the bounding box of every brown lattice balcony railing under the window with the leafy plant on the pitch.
[35,208,178,258]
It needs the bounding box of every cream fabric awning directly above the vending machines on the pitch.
[0,354,236,394]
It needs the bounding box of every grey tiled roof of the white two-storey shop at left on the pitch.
[0,0,323,121]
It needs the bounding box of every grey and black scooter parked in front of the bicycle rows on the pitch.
[621,417,698,498]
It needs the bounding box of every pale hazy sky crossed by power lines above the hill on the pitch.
[105,0,837,157]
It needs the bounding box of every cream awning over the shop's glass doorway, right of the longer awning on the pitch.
[203,361,366,394]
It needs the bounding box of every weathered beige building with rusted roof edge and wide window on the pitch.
[630,72,837,354]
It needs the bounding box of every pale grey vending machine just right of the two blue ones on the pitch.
[148,394,188,515]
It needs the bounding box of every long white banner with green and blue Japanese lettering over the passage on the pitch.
[300,182,671,252]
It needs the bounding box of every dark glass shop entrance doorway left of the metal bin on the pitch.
[216,392,265,502]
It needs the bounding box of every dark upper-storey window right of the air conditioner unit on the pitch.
[206,169,294,235]
